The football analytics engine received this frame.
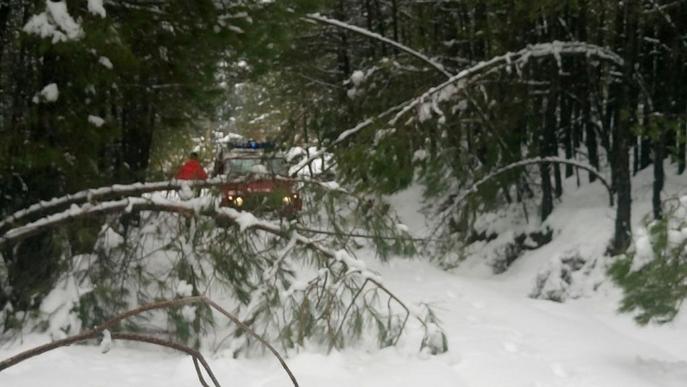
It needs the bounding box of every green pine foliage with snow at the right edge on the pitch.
[610,196,687,324]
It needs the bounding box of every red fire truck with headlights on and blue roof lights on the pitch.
[214,140,303,218]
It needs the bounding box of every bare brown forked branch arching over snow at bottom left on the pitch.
[0,295,298,387]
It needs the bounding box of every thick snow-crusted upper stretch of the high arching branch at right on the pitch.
[389,41,623,125]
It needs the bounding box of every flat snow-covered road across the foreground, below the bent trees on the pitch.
[0,261,687,387]
